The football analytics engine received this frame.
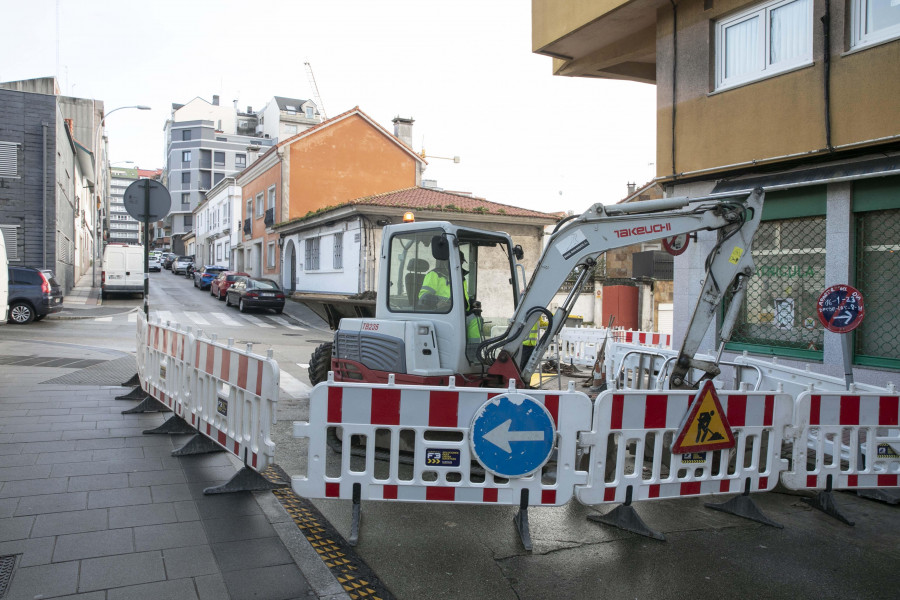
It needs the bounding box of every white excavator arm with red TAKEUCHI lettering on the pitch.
[479,189,764,387]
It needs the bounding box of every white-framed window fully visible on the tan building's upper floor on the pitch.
[716,0,813,89]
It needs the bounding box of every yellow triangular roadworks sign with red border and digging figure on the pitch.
[672,380,734,454]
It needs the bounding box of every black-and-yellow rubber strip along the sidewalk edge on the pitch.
[262,466,394,600]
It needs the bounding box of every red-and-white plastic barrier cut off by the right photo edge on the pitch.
[781,392,900,490]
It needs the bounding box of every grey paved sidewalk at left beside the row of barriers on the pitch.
[0,340,347,600]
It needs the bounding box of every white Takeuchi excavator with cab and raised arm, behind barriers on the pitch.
[310,189,764,388]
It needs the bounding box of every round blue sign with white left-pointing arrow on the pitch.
[469,392,556,477]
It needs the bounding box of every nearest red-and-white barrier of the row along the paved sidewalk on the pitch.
[192,340,279,471]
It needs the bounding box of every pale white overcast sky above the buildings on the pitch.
[0,0,656,213]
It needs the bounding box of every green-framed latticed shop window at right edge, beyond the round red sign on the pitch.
[855,209,900,367]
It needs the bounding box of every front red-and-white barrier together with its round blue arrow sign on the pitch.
[292,378,591,506]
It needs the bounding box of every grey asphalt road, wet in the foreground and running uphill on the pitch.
[8,271,900,600]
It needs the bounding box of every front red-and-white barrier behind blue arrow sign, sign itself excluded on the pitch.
[292,375,591,506]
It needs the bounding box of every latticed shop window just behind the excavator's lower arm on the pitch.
[731,216,825,352]
